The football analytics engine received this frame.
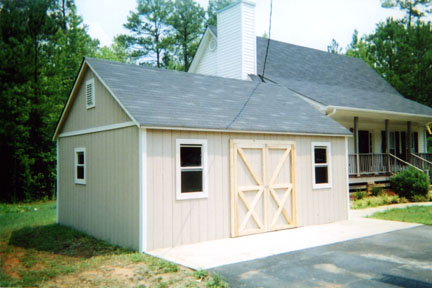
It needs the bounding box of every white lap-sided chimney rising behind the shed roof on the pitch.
[217,0,257,80]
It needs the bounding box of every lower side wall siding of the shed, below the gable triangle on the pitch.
[57,127,139,249]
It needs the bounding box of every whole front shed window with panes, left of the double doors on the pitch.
[176,139,208,200]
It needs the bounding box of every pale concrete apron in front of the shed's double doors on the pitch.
[148,203,432,270]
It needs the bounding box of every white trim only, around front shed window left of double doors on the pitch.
[176,139,208,200]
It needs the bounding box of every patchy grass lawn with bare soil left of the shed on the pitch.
[0,201,227,287]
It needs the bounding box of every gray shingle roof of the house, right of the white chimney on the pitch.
[257,37,432,116]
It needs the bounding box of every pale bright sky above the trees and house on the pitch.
[75,0,412,51]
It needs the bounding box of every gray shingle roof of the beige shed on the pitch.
[86,58,351,135]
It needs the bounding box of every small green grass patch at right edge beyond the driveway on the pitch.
[370,206,432,225]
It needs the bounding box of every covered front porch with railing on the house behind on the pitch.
[332,110,432,182]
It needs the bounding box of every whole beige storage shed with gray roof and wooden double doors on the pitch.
[54,58,351,251]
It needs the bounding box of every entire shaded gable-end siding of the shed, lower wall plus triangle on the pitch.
[57,68,139,249]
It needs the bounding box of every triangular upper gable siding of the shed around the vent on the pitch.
[61,69,131,132]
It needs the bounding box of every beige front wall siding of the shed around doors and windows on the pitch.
[147,130,348,250]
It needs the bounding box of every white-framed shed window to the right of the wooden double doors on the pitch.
[312,142,331,189]
